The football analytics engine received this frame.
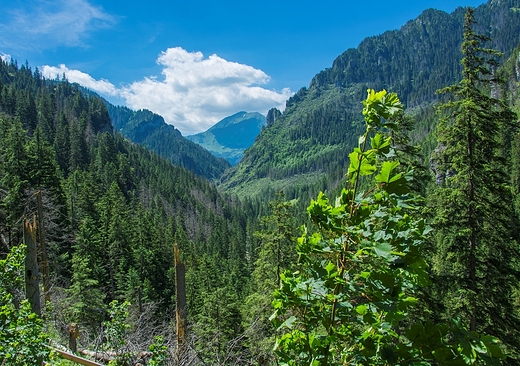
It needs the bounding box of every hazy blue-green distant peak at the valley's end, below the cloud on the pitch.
[186,112,266,165]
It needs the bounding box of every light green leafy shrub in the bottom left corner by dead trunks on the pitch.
[0,245,49,365]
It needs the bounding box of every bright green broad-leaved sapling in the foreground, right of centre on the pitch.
[273,90,502,365]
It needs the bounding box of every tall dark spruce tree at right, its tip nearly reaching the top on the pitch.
[432,8,520,357]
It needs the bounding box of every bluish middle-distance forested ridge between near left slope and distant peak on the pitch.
[105,102,230,180]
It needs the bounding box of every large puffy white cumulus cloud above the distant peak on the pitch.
[121,47,293,134]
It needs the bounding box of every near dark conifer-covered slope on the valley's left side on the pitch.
[0,61,264,360]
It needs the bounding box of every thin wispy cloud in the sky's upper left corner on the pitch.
[0,0,115,49]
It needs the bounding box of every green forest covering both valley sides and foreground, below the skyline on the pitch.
[0,0,520,365]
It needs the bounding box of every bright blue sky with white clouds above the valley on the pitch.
[0,0,484,135]
